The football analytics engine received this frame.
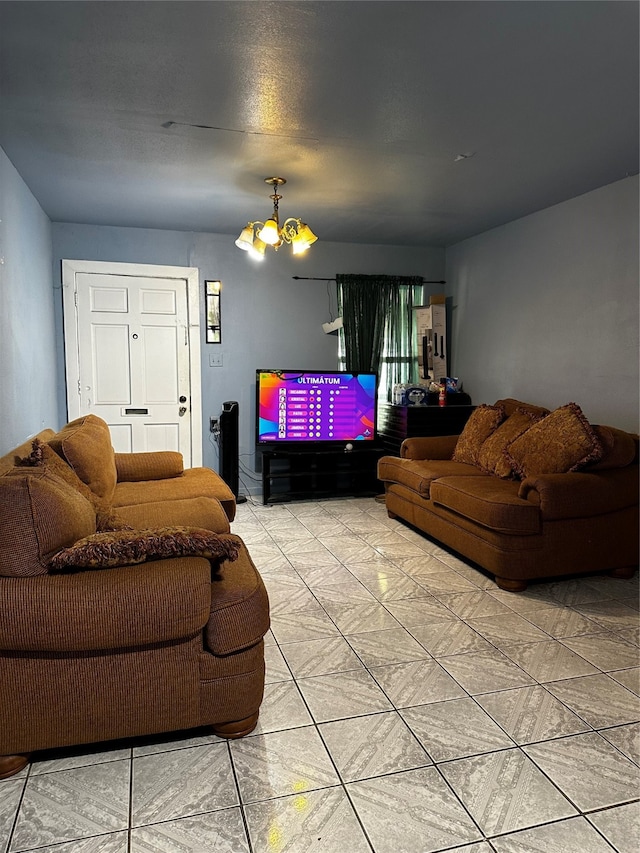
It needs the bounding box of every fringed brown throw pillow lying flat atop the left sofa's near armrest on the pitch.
[49,527,239,571]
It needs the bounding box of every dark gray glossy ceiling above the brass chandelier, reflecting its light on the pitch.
[0,0,639,246]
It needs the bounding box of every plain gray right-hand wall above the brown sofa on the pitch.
[446,176,638,432]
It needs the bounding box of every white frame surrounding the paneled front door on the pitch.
[62,259,202,468]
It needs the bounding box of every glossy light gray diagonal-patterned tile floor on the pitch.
[0,499,640,853]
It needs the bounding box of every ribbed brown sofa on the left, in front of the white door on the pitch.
[0,415,269,778]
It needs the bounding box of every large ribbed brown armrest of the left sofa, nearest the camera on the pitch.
[0,557,211,653]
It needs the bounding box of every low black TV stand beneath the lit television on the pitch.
[261,445,385,504]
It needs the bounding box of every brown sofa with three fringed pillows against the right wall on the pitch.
[378,399,638,591]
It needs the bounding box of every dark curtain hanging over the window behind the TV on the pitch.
[336,274,422,382]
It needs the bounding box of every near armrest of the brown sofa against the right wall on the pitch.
[518,465,638,521]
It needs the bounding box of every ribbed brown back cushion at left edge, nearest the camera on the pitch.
[0,468,96,577]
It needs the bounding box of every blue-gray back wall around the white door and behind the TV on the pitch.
[53,223,445,493]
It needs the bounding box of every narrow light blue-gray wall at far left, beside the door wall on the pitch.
[0,148,60,454]
